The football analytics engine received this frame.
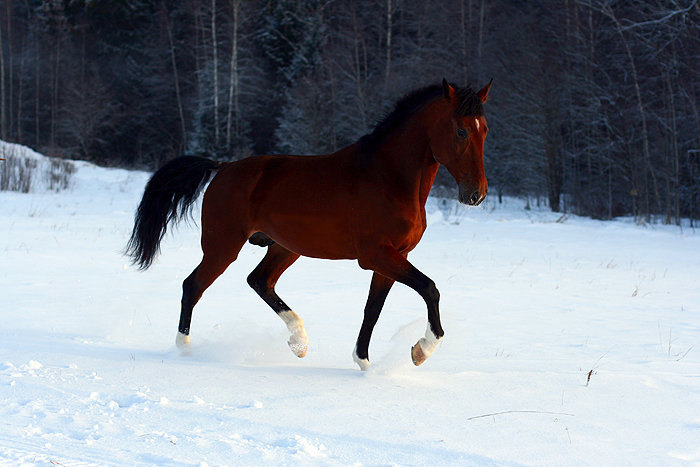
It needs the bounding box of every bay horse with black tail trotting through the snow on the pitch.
[126,78,493,370]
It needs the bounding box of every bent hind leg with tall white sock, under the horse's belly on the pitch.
[248,244,309,358]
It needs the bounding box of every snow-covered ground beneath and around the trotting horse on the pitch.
[0,144,700,465]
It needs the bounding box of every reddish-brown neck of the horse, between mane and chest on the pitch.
[376,116,440,206]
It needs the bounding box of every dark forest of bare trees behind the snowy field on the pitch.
[0,0,700,223]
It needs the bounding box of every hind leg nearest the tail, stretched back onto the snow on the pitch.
[175,231,246,349]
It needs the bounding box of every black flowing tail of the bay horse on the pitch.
[125,156,220,269]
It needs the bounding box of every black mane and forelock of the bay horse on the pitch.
[360,84,484,153]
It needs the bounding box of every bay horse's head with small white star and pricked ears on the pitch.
[429,79,493,206]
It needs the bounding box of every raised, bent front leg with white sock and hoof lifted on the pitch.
[359,246,445,365]
